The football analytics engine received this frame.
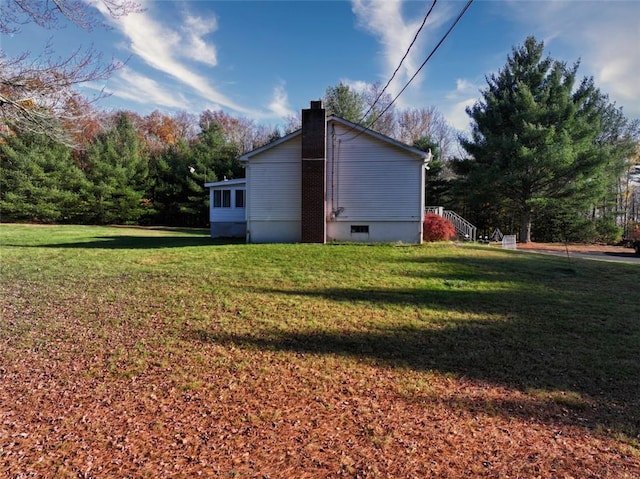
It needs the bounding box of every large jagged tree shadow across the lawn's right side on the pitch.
[186,256,640,440]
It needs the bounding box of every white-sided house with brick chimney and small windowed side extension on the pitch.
[205,101,430,243]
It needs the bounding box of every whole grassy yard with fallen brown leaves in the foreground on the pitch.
[0,225,640,479]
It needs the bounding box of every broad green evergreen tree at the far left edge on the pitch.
[0,133,89,223]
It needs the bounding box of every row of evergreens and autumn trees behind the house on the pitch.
[0,84,455,227]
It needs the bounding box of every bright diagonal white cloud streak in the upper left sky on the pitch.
[90,0,254,114]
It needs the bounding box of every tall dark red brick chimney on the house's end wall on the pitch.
[301,101,327,243]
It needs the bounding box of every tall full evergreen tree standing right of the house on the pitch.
[462,37,624,242]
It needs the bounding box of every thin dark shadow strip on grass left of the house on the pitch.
[6,235,245,249]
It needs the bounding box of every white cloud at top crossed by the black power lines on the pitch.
[351,0,449,104]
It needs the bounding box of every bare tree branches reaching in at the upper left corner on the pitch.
[0,0,139,144]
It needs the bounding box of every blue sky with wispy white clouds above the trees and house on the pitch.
[1,0,640,129]
